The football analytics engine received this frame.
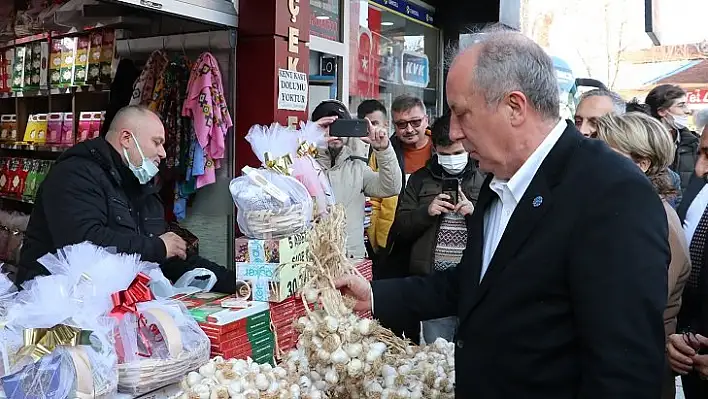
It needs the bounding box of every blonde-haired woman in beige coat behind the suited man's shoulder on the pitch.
[597,112,691,399]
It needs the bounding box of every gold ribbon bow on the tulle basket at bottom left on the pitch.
[17,324,92,362]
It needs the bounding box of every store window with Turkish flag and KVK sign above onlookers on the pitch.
[349,0,441,119]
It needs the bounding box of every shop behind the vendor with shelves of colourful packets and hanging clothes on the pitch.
[0,0,238,266]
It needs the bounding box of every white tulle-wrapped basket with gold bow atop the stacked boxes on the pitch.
[229,125,313,239]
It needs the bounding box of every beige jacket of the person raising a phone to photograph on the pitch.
[317,145,403,259]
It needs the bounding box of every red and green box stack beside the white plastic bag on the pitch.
[175,293,275,364]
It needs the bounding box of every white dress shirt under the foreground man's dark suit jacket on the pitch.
[479,119,568,281]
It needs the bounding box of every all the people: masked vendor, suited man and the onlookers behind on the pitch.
[4,23,708,399]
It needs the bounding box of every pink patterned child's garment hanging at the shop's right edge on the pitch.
[182,53,233,188]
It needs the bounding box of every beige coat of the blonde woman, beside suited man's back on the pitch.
[663,201,691,337]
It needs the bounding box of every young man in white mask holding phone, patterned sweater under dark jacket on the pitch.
[393,114,485,344]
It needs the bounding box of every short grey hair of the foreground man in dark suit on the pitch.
[450,26,560,119]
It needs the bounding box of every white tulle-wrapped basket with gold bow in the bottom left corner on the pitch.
[0,275,118,398]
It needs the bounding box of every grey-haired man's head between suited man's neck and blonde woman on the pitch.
[575,89,626,137]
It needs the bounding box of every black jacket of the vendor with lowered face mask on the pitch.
[17,138,236,292]
